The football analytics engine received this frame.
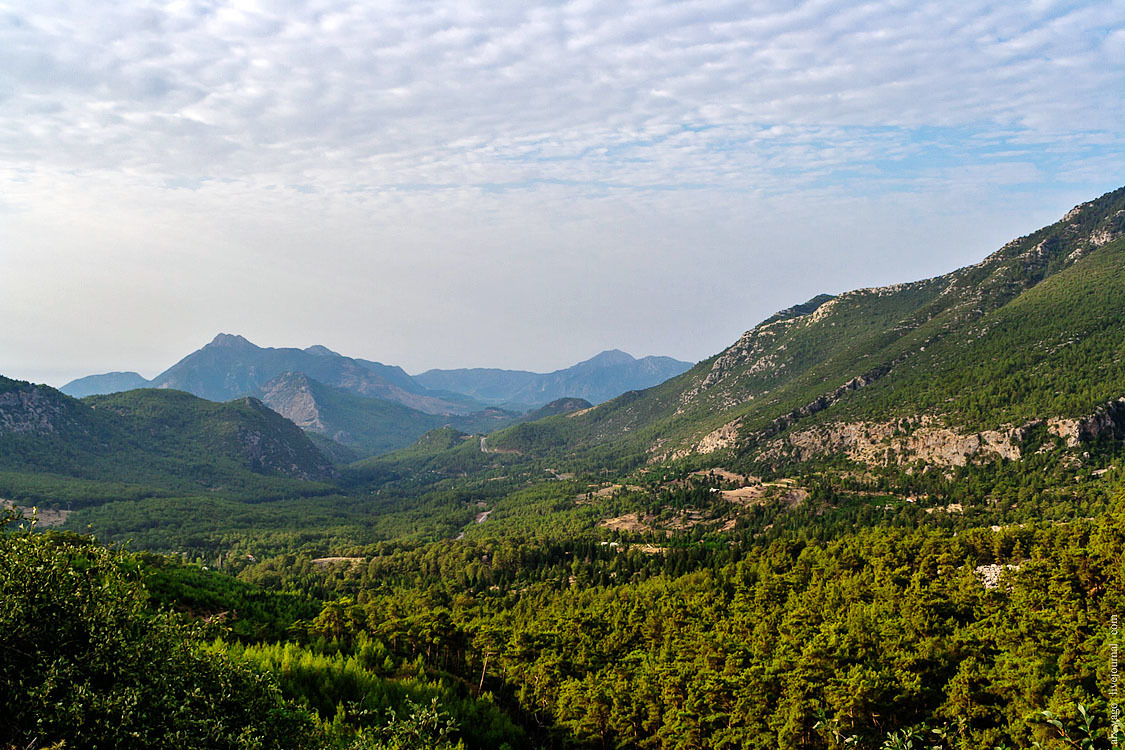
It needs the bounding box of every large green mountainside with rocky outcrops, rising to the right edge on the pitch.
[489,189,1125,470]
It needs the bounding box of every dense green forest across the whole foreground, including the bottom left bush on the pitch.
[0,452,1125,749]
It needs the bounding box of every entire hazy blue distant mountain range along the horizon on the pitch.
[61,333,691,458]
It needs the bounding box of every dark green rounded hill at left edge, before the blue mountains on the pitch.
[0,378,335,499]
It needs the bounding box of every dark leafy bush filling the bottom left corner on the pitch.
[0,517,315,749]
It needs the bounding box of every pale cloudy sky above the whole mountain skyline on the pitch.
[0,0,1125,386]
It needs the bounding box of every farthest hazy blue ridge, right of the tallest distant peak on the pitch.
[414,349,692,407]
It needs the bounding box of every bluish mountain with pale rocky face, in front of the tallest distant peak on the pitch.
[259,372,515,457]
